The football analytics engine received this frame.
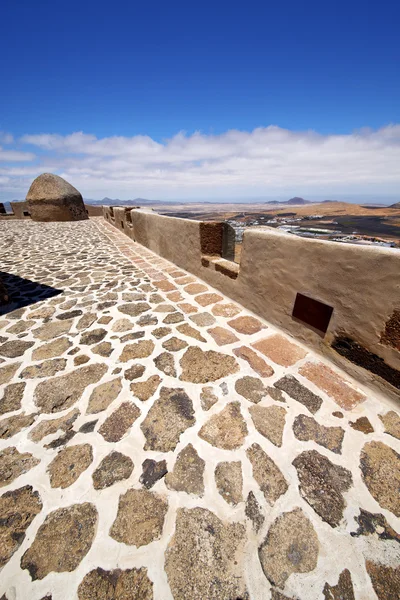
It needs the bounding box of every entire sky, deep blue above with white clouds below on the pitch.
[0,0,400,200]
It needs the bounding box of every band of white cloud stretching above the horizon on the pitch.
[0,125,400,199]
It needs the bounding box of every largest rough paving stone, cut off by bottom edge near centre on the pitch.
[165,507,249,600]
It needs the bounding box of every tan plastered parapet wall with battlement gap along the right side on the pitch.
[103,207,400,394]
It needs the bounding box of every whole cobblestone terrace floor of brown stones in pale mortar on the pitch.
[0,220,400,600]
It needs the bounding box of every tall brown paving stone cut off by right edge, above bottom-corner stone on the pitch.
[360,442,400,517]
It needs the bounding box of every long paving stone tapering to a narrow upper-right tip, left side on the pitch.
[35,364,107,413]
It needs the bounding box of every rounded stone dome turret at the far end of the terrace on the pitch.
[26,173,88,221]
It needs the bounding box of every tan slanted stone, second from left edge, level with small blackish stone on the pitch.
[47,444,93,488]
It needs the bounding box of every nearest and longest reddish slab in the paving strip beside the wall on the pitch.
[299,363,366,410]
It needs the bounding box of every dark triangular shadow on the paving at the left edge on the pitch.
[0,271,63,315]
